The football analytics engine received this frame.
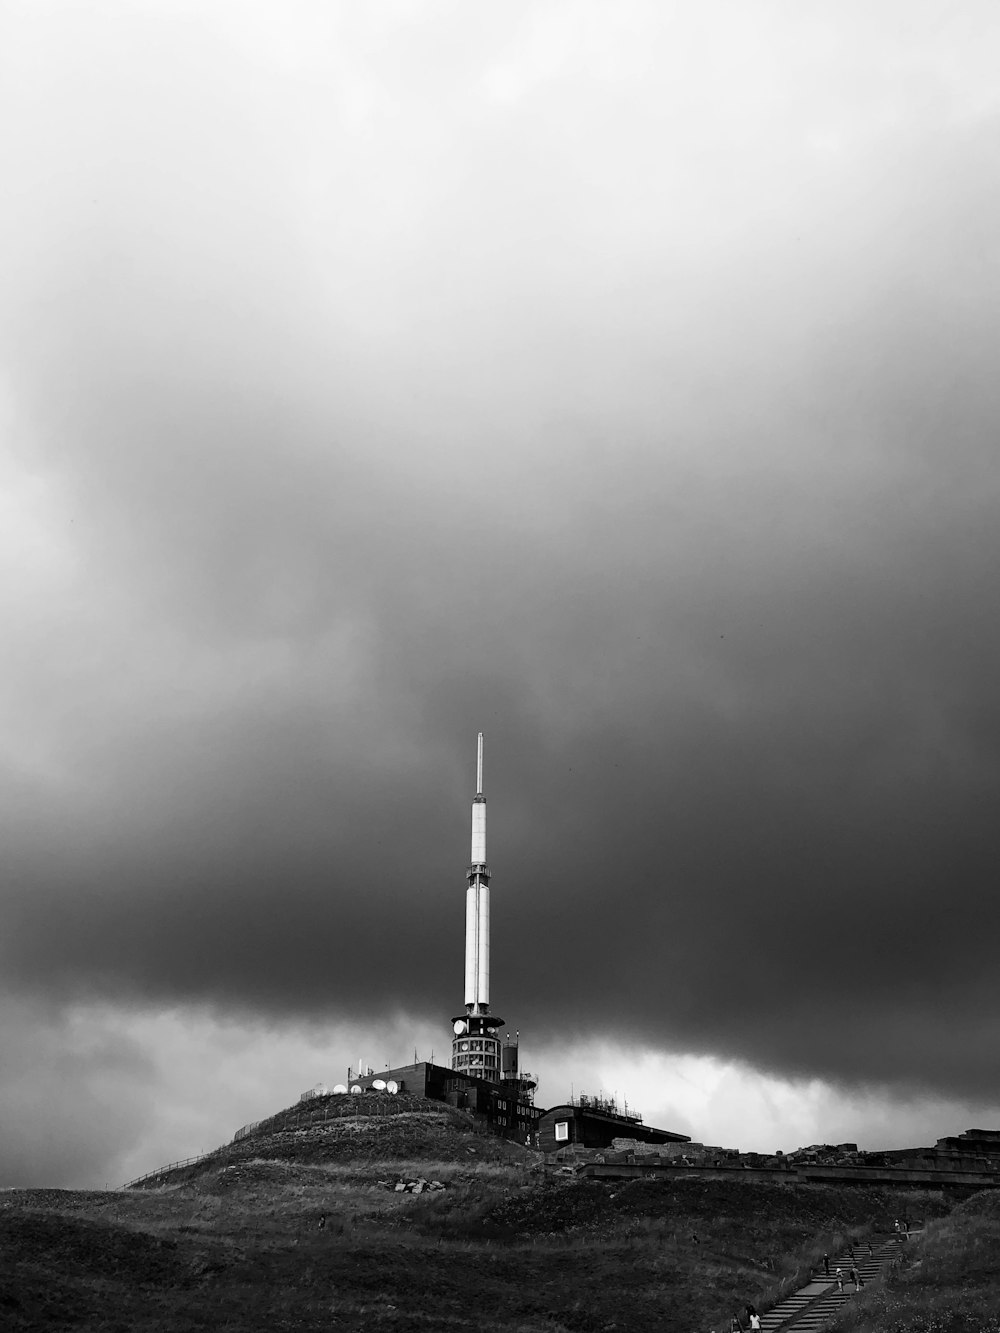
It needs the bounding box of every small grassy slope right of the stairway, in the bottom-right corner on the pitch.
[836,1190,1000,1333]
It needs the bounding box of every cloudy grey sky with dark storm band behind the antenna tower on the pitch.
[0,0,1000,1188]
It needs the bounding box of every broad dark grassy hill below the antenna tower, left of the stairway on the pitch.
[0,1098,981,1333]
